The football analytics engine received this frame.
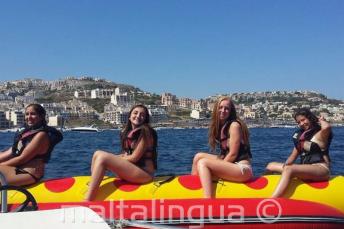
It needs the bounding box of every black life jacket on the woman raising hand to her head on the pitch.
[293,127,332,164]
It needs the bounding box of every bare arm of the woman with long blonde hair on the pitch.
[224,122,242,162]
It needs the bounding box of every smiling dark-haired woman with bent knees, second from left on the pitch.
[85,105,157,201]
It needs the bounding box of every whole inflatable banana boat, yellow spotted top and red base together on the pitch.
[8,175,344,228]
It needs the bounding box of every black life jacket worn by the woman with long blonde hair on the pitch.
[216,120,252,162]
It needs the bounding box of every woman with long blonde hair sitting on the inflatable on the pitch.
[191,97,253,198]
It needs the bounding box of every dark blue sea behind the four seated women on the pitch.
[0,127,344,179]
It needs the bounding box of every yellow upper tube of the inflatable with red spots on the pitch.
[8,175,344,213]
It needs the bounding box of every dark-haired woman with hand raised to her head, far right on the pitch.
[266,108,332,197]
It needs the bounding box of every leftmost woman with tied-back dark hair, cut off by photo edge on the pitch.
[0,104,63,186]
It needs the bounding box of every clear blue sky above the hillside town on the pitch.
[0,0,344,99]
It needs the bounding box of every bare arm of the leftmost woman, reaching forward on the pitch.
[0,132,50,166]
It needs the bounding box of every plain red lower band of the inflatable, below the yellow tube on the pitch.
[35,198,344,220]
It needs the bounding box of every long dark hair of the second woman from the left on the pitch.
[120,104,152,149]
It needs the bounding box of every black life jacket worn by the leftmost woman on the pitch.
[12,125,63,163]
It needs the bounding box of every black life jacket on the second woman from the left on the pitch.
[122,127,158,169]
